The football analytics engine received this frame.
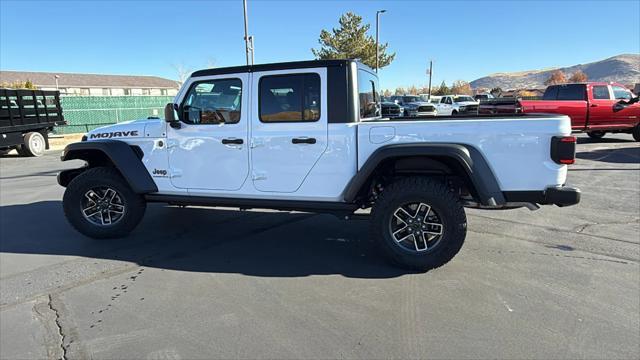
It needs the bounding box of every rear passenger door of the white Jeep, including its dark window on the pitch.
[251,68,328,193]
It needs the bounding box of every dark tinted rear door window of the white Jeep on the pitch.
[258,74,320,123]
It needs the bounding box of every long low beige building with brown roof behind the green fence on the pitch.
[0,71,179,96]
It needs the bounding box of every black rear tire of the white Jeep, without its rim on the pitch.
[370,177,467,271]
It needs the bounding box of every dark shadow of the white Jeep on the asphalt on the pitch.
[0,201,410,278]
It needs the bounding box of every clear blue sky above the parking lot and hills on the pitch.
[0,0,640,88]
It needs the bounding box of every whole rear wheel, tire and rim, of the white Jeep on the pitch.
[370,177,467,271]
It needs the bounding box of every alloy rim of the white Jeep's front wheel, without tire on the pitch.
[81,187,126,226]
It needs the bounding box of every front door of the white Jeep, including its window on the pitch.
[167,74,250,192]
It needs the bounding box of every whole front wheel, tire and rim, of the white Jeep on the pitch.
[63,167,146,239]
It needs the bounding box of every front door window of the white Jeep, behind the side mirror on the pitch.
[179,79,242,125]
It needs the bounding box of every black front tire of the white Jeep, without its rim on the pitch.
[62,167,147,239]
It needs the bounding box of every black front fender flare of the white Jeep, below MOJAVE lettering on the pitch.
[58,140,158,194]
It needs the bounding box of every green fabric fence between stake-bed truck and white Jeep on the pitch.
[54,96,173,134]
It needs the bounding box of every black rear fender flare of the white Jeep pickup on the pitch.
[344,143,506,206]
